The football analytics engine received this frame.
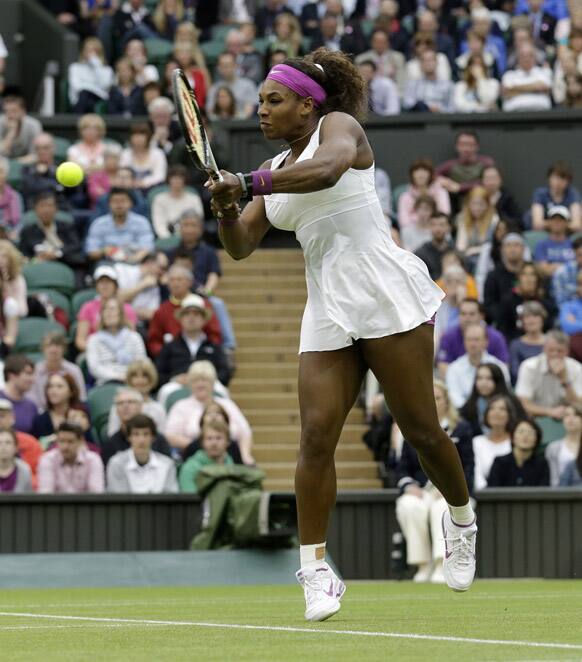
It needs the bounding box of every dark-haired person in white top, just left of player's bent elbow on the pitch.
[152,165,204,239]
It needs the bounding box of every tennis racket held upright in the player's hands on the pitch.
[172,69,222,182]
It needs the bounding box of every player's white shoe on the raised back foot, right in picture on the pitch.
[442,511,477,591]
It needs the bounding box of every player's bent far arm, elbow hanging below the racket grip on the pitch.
[212,161,271,260]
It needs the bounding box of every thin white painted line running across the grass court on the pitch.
[0,611,582,651]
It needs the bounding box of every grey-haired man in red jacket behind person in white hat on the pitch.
[147,266,222,357]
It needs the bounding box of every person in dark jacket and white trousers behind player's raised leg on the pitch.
[396,381,474,584]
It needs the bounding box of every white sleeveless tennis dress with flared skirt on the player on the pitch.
[265,116,445,353]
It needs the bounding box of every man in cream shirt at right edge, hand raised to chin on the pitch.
[515,330,582,420]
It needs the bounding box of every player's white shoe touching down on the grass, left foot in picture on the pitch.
[295,562,346,621]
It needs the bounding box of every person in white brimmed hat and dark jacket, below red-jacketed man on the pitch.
[156,294,231,386]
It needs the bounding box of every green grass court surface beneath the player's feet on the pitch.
[0,577,582,662]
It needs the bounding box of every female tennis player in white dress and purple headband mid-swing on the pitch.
[206,48,477,621]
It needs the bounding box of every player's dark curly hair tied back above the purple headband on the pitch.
[285,47,368,121]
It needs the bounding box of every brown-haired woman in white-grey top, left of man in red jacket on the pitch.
[87,298,146,385]
